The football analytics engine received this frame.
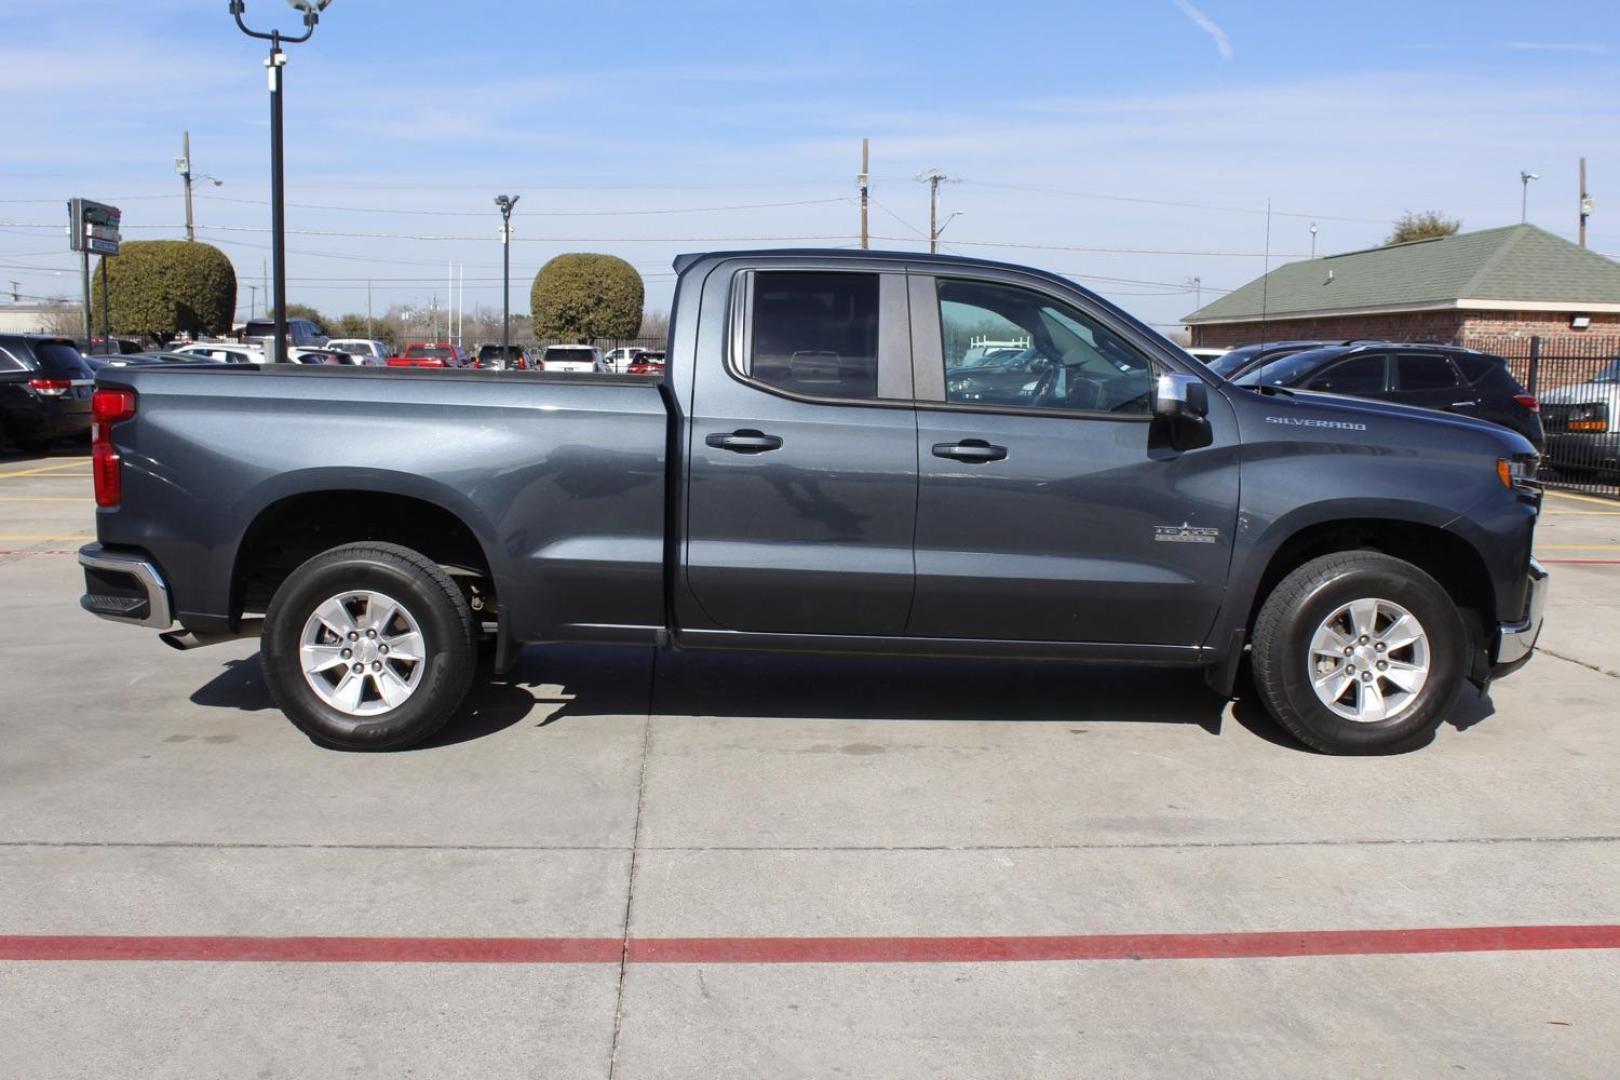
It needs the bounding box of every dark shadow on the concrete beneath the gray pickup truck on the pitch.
[191,646,1494,753]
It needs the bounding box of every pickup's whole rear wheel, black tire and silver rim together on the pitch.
[261,542,478,750]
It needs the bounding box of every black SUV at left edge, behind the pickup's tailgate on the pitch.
[0,334,96,452]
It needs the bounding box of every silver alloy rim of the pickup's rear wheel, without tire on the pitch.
[298,589,428,716]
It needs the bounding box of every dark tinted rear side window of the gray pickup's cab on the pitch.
[747,270,880,400]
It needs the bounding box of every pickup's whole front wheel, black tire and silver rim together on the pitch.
[1252,551,1468,755]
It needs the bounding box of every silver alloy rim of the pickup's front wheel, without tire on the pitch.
[1307,599,1430,724]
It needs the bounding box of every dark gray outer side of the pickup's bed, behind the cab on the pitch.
[97,364,669,641]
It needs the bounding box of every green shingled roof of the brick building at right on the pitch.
[1184,225,1620,324]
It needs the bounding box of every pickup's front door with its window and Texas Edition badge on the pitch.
[907,277,1238,646]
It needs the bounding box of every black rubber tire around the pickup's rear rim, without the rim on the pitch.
[261,542,478,750]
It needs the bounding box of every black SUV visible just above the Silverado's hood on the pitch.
[1234,342,1547,450]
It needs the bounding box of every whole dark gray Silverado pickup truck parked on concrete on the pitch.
[79,251,1545,753]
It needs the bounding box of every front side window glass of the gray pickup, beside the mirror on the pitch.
[938,279,1153,416]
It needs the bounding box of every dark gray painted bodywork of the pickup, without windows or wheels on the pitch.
[85,251,1536,683]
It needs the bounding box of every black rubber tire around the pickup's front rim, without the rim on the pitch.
[1252,551,1468,755]
